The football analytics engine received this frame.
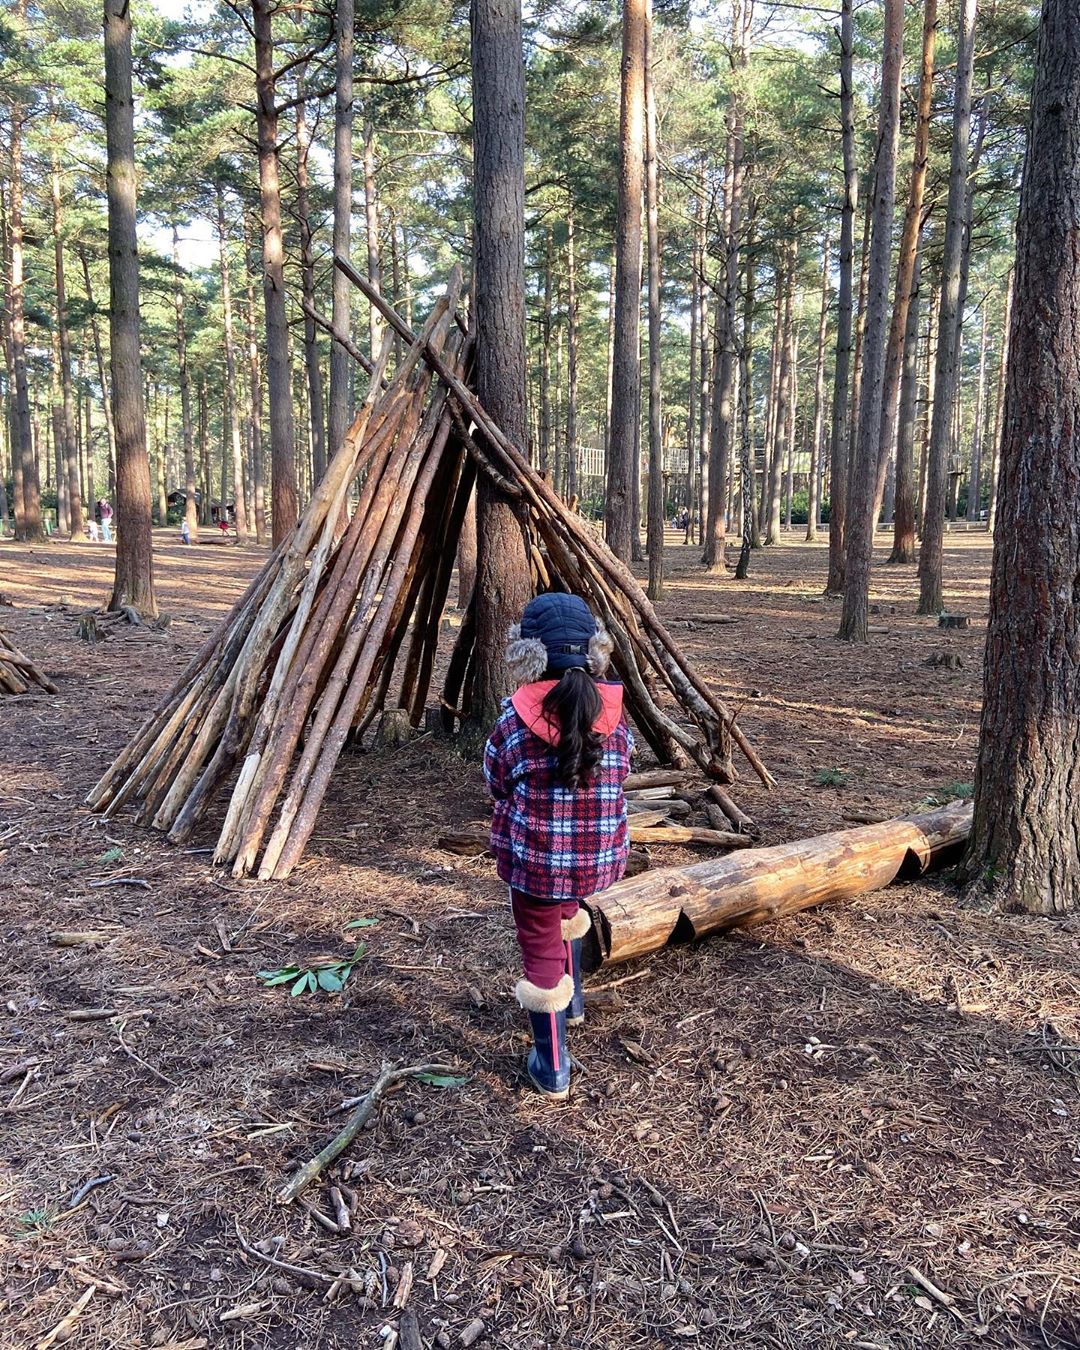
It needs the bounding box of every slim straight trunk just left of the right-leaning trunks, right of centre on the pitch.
[825,0,859,595]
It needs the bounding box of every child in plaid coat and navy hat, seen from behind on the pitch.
[483,594,633,1100]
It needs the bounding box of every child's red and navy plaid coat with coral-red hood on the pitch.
[483,684,633,900]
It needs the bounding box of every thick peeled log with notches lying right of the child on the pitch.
[583,802,972,969]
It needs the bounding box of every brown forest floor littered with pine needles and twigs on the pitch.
[0,532,1080,1350]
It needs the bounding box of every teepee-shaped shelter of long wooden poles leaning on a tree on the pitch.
[88,267,772,878]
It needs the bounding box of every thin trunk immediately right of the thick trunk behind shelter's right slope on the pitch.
[645,0,661,601]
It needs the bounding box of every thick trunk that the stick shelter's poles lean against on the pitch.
[470,0,531,734]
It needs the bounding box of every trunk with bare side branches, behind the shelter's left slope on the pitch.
[251,0,299,547]
